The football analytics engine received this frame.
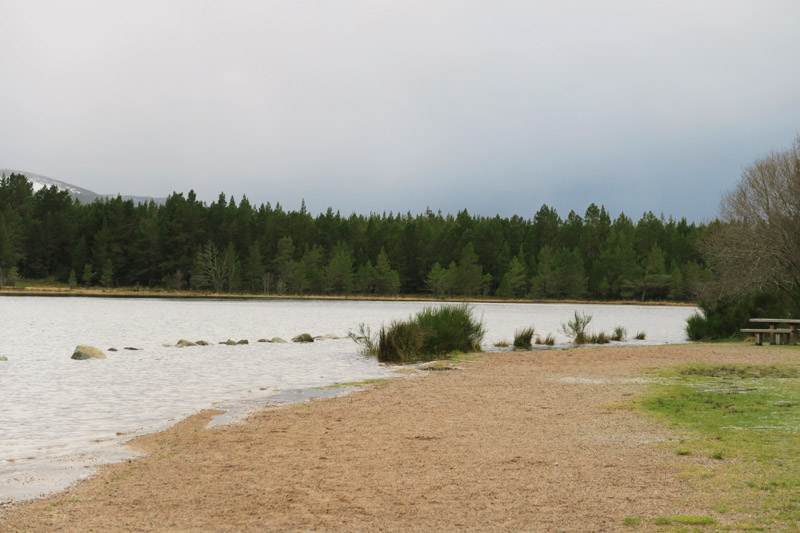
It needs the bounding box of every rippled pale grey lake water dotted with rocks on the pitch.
[0,296,695,500]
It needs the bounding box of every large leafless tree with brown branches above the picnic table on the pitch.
[704,136,800,301]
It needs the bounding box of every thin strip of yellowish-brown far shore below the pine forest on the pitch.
[0,285,697,307]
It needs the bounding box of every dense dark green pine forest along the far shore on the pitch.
[0,174,713,301]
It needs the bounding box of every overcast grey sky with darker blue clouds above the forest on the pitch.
[0,0,800,222]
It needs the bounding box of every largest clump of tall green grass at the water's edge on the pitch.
[350,304,486,363]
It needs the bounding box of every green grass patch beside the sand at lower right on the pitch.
[636,364,800,531]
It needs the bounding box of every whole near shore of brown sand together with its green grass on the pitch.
[0,344,800,531]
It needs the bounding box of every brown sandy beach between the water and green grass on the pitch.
[0,345,797,531]
